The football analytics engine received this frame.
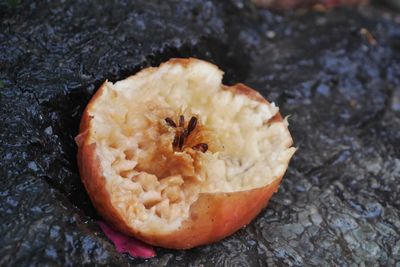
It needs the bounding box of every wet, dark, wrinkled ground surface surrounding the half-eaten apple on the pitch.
[0,0,400,266]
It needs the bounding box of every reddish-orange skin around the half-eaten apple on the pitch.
[76,59,291,249]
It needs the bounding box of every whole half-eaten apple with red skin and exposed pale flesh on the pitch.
[76,58,295,249]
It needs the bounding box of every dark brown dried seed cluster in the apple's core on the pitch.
[165,115,208,153]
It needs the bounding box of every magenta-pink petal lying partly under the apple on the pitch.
[97,221,156,259]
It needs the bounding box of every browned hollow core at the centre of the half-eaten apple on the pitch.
[130,110,222,180]
